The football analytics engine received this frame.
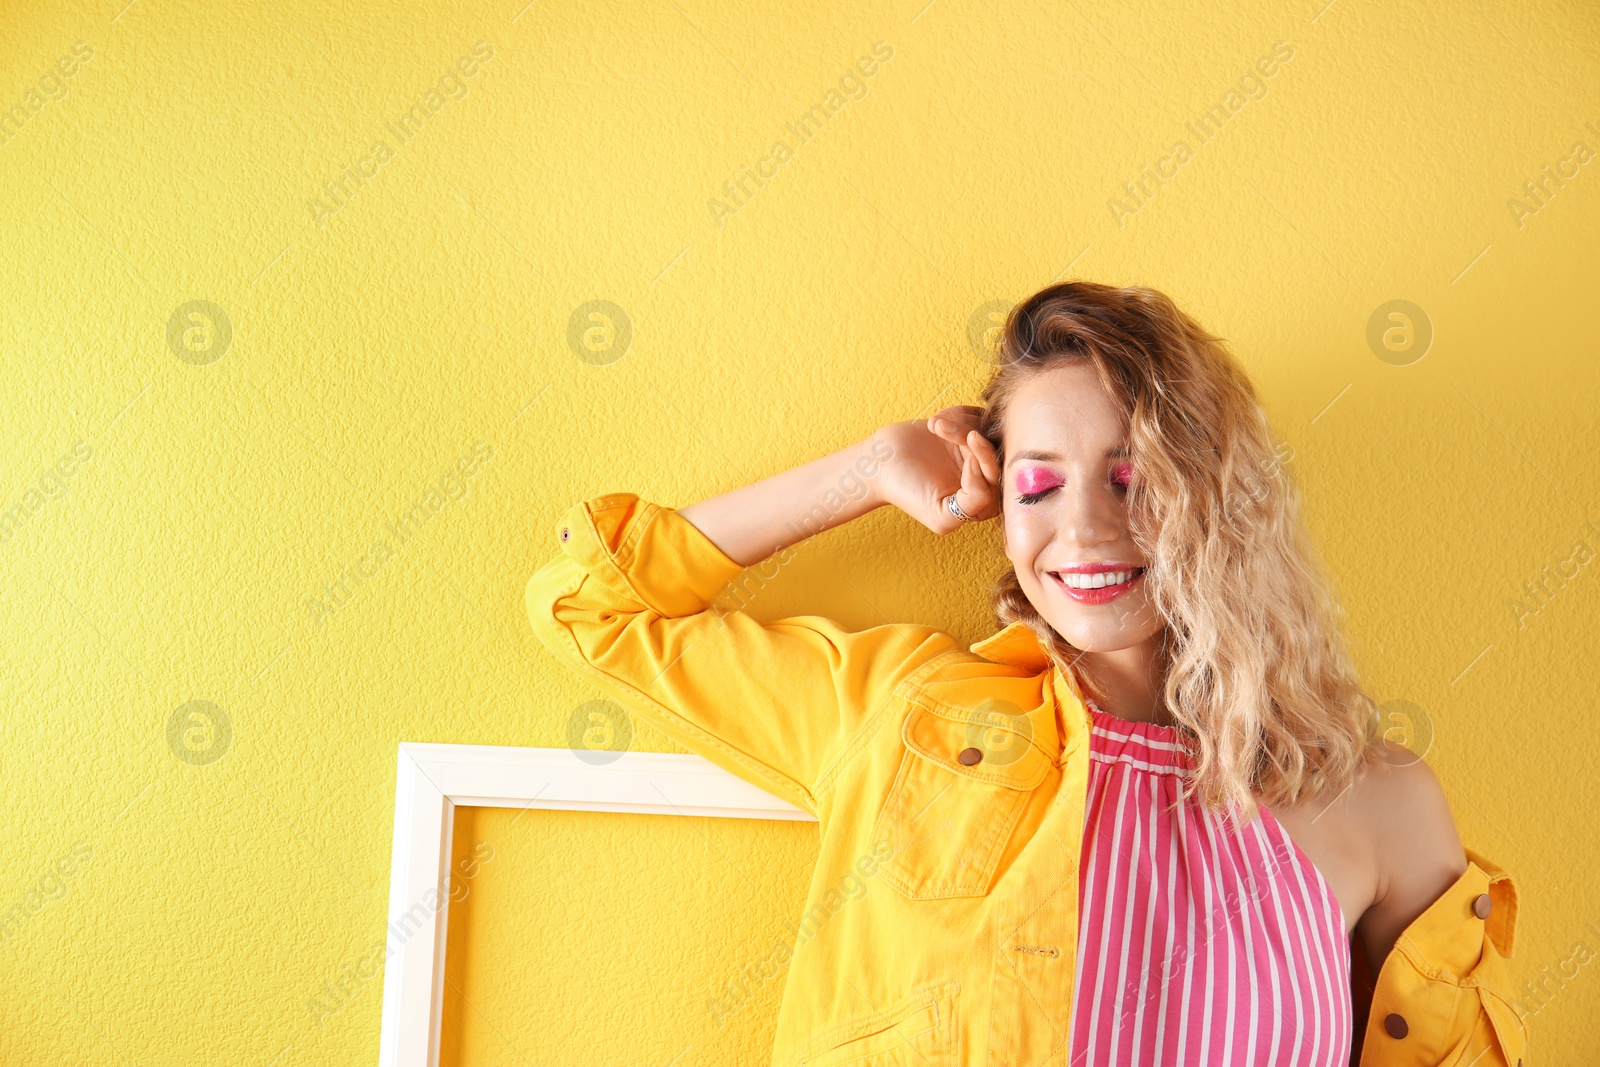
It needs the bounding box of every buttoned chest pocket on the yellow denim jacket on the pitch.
[874,702,1051,901]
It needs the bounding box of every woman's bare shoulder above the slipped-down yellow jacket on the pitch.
[1350,741,1467,969]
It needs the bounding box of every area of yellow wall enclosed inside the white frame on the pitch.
[440,808,816,1067]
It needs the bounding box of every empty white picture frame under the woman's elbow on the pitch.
[378,742,816,1067]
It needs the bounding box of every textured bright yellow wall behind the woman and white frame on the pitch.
[0,0,1600,1067]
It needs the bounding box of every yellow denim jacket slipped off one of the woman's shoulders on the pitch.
[526,493,1526,1067]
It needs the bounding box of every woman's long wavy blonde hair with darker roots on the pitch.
[981,282,1382,822]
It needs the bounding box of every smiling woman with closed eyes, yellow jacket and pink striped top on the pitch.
[528,282,1526,1067]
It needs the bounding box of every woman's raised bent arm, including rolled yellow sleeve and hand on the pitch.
[525,413,990,814]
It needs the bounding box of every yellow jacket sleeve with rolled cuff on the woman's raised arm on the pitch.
[526,493,957,814]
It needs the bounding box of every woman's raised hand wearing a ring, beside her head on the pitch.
[877,405,1000,534]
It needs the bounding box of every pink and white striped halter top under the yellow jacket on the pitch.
[1070,701,1352,1067]
